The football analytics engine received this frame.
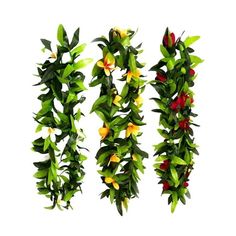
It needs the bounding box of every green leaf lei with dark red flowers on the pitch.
[150,28,202,212]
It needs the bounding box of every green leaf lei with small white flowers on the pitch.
[32,25,91,209]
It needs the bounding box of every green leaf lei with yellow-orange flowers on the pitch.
[90,28,148,215]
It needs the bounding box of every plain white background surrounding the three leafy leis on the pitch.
[0,0,236,236]
